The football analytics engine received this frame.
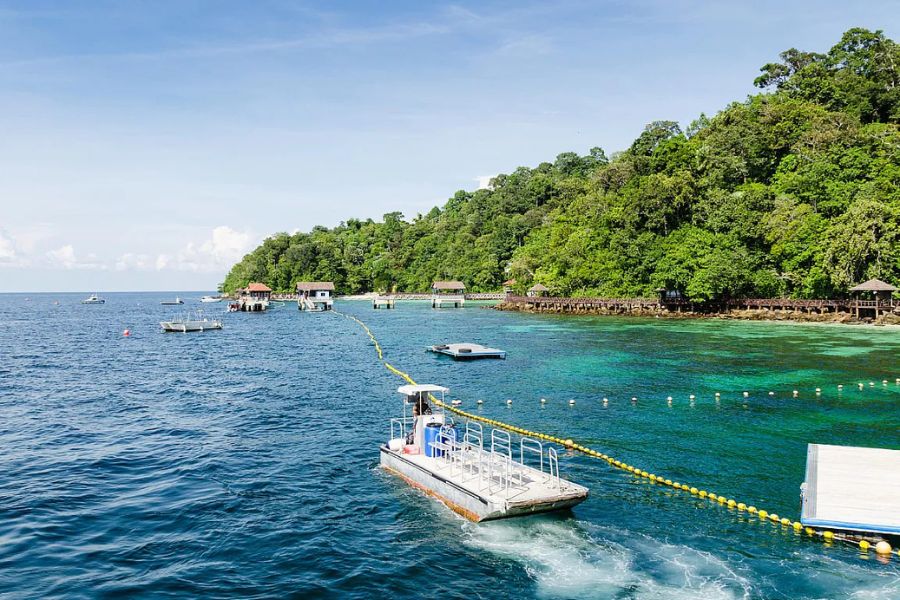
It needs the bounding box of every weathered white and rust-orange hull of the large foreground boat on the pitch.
[381,446,588,523]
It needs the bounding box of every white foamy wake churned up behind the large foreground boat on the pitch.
[464,519,751,600]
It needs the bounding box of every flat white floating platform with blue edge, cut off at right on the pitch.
[800,444,900,535]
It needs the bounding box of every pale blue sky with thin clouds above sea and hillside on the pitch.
[0,0,900,291]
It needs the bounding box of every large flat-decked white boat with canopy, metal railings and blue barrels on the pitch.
[380,385,589,522]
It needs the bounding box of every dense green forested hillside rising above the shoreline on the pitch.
[224,29,900,299]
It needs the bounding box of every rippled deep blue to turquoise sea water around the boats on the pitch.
[0,293,900,598]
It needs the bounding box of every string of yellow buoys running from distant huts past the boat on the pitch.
[333,311,900,556]
